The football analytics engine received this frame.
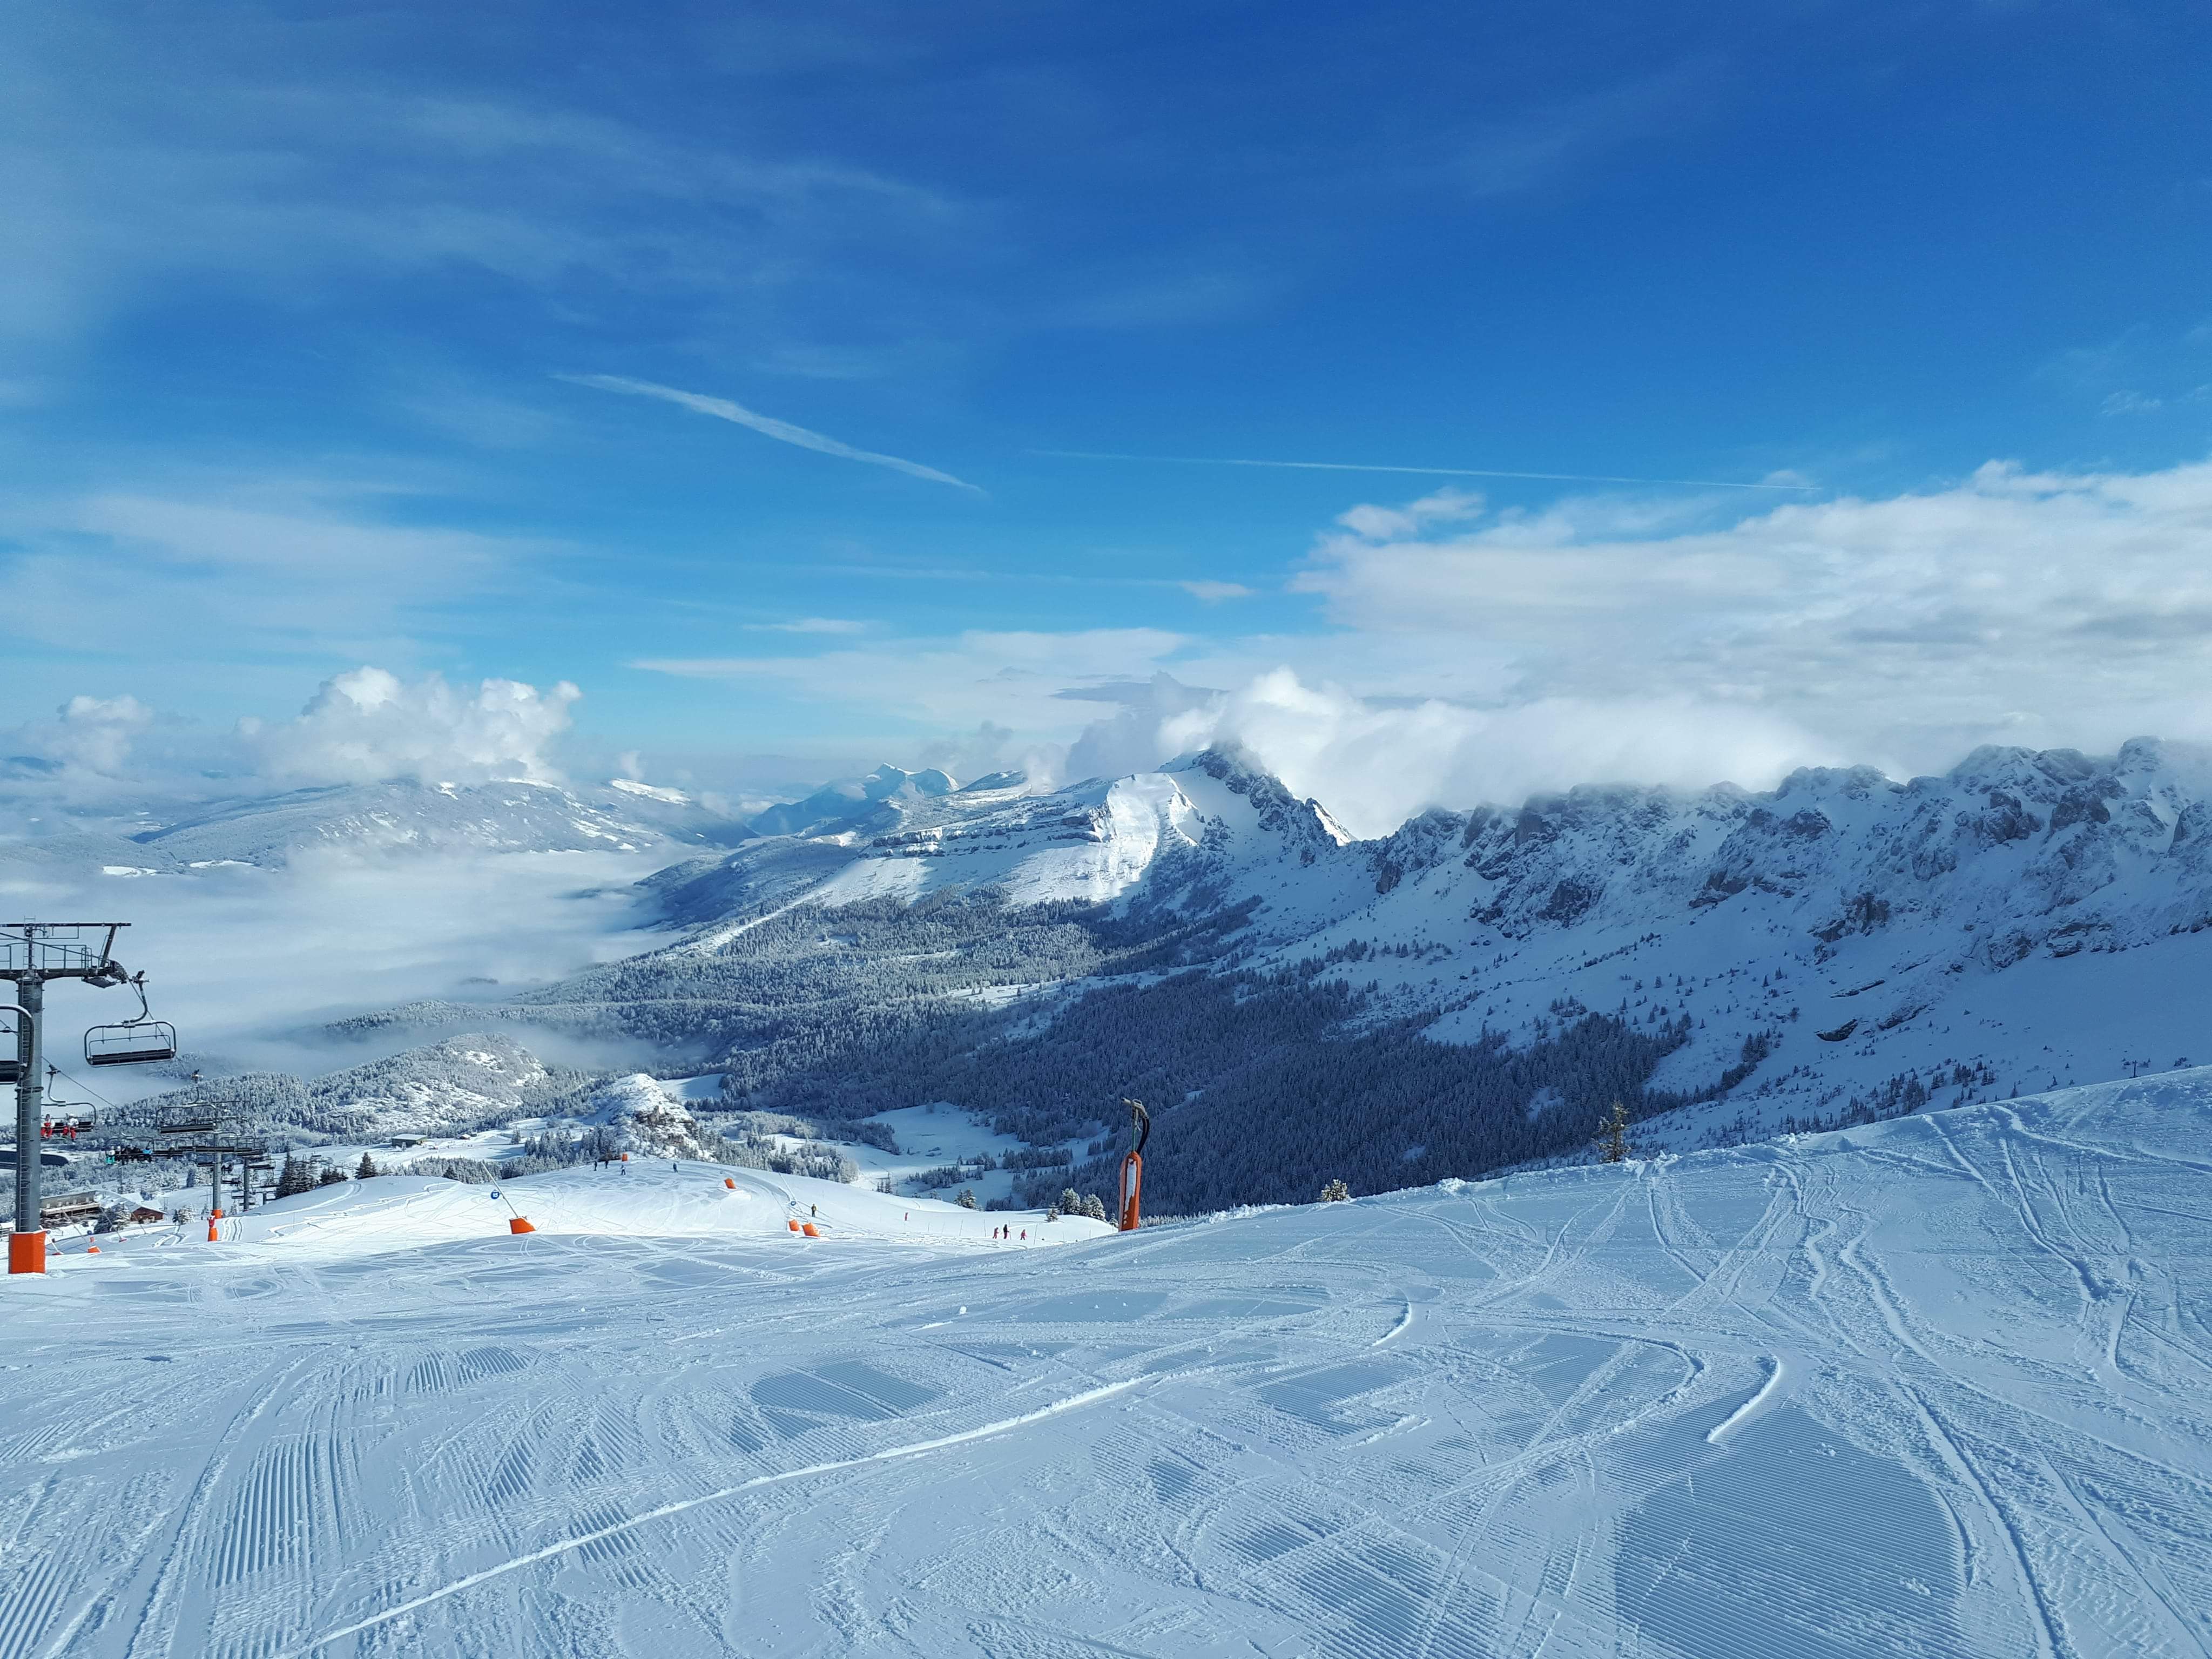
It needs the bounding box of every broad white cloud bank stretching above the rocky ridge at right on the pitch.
[1292,462,2212,767]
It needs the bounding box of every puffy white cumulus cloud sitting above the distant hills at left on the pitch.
[241,668,582,783]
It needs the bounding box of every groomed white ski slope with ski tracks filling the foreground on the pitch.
[0,1070,2212,1659]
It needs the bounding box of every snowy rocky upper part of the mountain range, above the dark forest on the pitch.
[615,739,2212,1194]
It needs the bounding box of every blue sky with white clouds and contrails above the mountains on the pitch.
[0,0,2212,810]
